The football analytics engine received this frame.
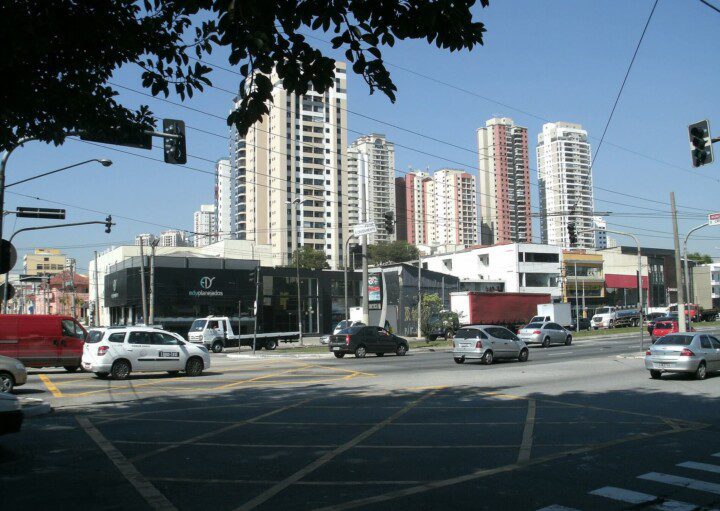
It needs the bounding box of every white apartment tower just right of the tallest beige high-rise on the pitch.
[347,133,396,244]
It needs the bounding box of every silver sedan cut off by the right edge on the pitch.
[645,332,720,380]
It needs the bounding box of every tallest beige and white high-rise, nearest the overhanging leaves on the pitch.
[236,62,349,268]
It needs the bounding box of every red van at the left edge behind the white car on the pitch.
[0,314,86,372]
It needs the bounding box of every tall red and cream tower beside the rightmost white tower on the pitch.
[477,117,532,245]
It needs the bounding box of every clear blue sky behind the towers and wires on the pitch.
[5,0,720,280]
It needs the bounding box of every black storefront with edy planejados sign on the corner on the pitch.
[105,257,361,335]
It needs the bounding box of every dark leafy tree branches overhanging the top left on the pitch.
[0,0,489,149]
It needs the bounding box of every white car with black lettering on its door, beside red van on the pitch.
[82,327,210,380]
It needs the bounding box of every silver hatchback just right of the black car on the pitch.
[453,325,530,365]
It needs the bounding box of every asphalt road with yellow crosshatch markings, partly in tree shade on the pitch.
[0,332,720,511]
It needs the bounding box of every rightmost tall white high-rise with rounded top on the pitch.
[537,122,595,248]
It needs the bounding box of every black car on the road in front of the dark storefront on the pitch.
[328,326,410,358]
